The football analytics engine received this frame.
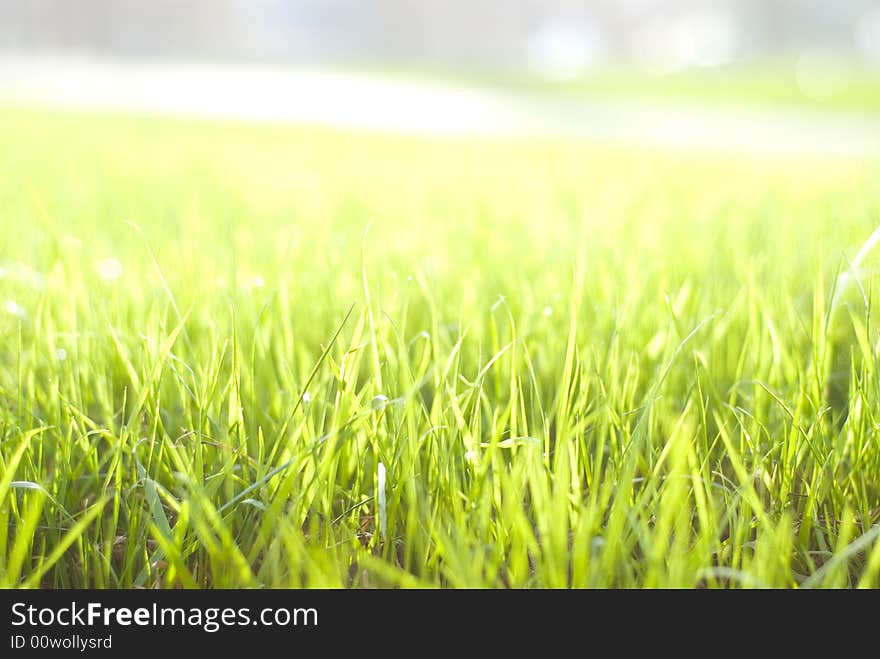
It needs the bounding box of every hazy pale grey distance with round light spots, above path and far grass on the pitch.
[0,0,880,78]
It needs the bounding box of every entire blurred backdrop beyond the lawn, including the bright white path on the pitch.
[0,0,880,153]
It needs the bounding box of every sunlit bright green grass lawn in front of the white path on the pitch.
[0,110,880,588]
